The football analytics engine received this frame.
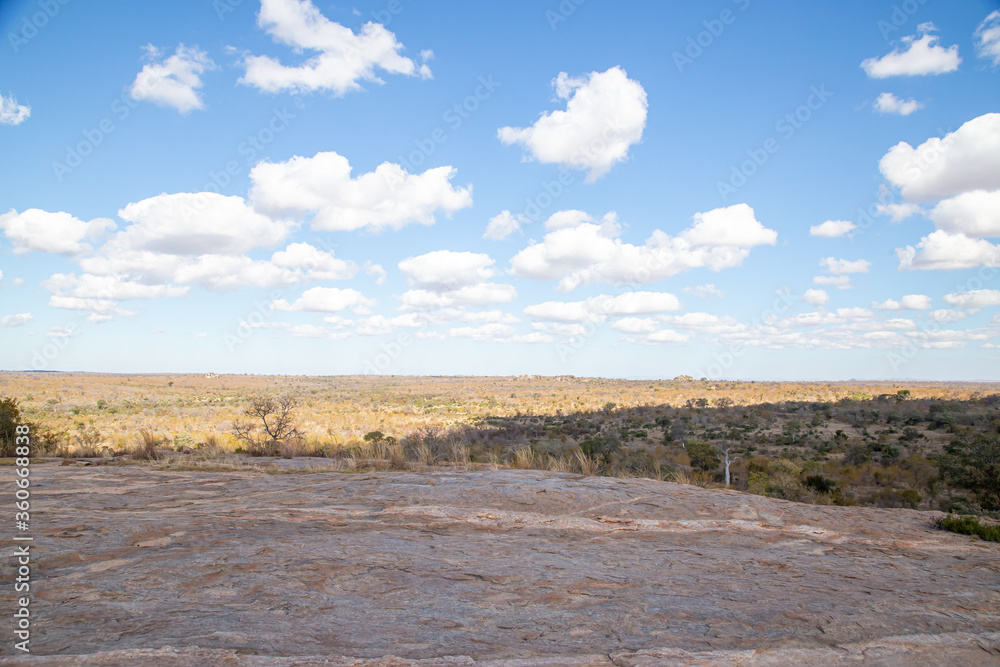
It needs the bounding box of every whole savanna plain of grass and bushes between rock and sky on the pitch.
[0,373,1000,518]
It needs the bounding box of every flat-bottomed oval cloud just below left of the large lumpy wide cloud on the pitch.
[116,192,291,255]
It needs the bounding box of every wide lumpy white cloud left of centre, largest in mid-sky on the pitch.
[250,152,472,231]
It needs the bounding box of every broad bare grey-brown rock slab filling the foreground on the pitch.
[0,464,1000,667]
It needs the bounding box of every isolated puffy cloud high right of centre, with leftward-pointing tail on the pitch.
[497,67,647,183]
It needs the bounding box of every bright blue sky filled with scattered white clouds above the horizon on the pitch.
[0,0,1000,380]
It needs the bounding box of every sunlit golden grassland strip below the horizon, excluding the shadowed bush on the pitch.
[0,372,1000,449]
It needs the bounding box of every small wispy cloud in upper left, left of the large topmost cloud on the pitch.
[129,44,215,113]
